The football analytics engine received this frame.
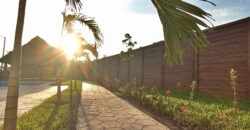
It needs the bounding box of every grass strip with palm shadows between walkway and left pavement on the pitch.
[0,81,82,130]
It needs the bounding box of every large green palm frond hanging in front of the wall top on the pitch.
[152,0,216,65]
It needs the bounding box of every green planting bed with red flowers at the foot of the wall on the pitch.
[114,86,250,129]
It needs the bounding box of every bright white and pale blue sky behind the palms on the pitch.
[0,0,250,57]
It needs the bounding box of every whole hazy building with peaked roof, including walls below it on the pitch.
[0,36,67,80]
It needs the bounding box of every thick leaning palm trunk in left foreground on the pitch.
[3,0,26,130]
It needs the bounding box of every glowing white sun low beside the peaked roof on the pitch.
[62,35,78,59]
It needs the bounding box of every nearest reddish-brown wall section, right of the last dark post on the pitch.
[198,20,248,97]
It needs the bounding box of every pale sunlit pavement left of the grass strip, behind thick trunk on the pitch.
[0,86,67,124]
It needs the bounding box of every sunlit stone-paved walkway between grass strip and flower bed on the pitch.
[77,83,168,130]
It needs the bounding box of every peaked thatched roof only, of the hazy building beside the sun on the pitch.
[0,36,66,65]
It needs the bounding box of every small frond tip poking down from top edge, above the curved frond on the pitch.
[65,0,82,12]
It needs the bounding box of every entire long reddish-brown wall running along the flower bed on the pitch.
[86,18,250,98]
